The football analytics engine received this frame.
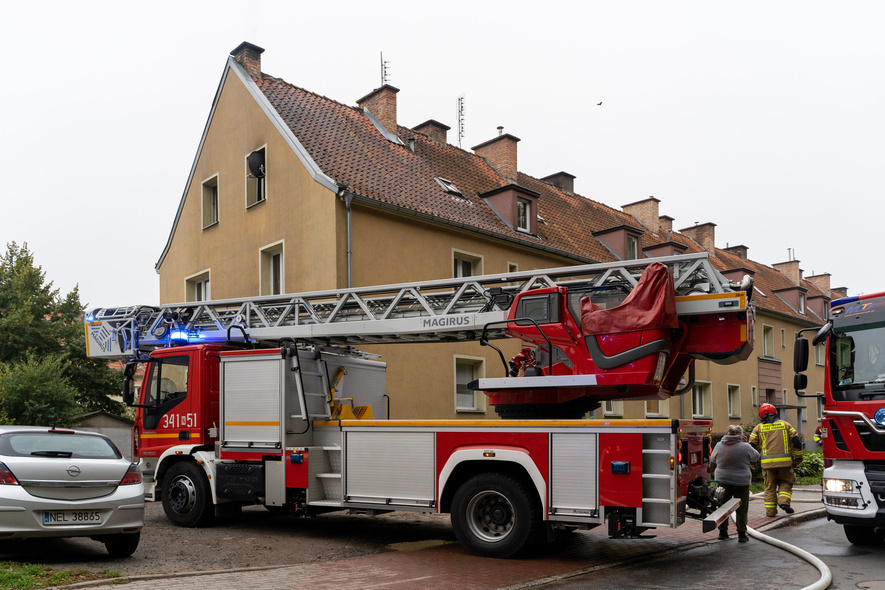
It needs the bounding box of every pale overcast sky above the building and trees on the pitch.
[0,0,885,307]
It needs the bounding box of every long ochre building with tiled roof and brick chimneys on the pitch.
[156,43,830,444]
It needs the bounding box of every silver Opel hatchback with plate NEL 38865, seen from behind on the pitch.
[0,426,144,557]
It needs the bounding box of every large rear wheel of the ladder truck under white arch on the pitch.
[452,473,543,557]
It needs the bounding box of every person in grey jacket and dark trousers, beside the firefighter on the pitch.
[710,424,759,543]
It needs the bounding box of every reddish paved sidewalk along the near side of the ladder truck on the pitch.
[62,486,826,590]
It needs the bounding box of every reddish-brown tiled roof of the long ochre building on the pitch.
[245,74,829,328]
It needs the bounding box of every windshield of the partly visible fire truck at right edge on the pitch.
[830,322,885,390]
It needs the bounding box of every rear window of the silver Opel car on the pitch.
[0,432,122,459]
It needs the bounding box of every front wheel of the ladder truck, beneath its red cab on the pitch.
[163,461,214,527]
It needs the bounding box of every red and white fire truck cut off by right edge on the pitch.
[794,293,885,545]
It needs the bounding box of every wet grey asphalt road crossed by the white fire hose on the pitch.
[541,518,885,590]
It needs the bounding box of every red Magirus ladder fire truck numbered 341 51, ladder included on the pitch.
[85,254,753,557]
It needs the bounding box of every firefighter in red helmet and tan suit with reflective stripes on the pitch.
[749,404,802,516]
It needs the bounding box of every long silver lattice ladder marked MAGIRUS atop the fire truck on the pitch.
[85,253,748,358]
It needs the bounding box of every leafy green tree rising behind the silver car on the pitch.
[0,242,123,423]
